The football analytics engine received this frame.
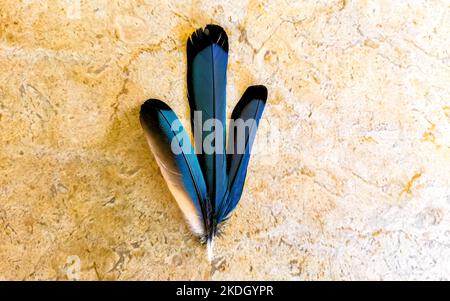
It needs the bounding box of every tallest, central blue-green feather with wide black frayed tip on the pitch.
[187,25,228,216]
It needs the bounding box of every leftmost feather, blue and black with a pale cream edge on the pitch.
[140,99,209,236]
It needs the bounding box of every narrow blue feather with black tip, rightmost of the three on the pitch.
[217,86,267,221]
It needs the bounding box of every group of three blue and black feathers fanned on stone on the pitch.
[140,25,267,260]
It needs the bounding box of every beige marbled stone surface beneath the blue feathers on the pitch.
[0,0,450,280]
